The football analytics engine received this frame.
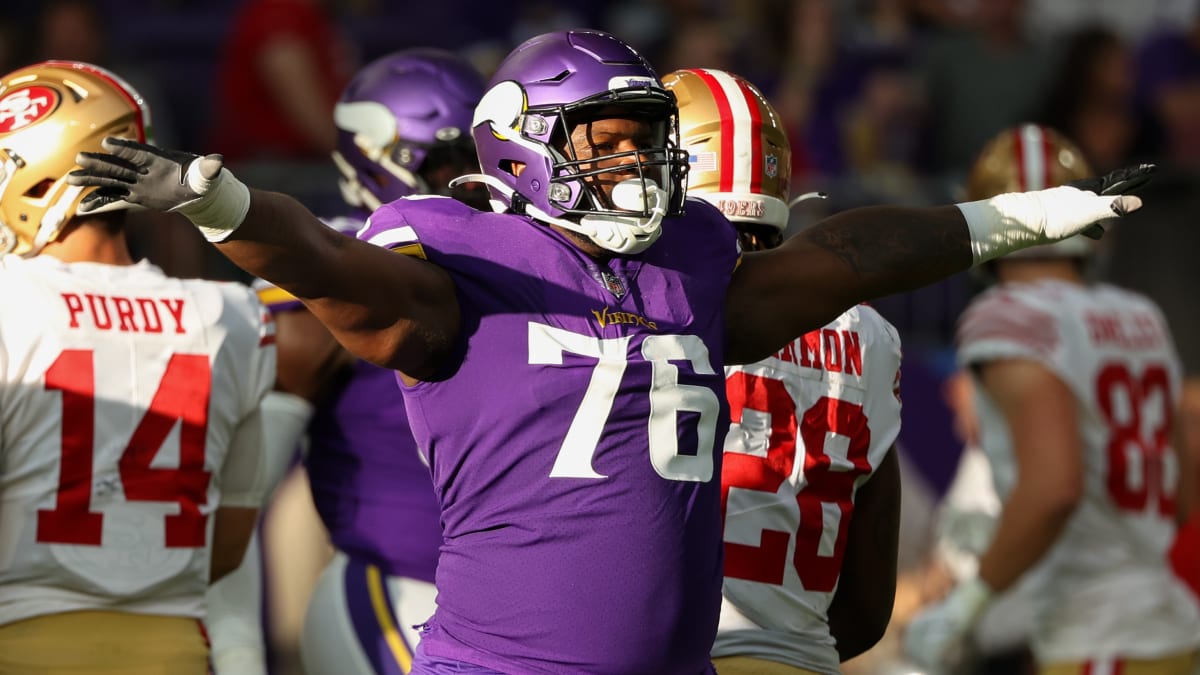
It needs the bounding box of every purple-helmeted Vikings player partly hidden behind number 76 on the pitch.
[215,48,487,675]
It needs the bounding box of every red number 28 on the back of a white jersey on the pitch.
[721,371,871,592]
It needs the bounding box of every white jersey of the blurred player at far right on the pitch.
[959,276,1200,663]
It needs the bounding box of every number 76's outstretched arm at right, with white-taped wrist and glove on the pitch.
[726,165,1153,364]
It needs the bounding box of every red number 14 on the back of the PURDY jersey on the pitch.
[37,350,211,548]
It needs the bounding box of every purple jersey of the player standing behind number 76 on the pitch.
[256,217,442,583]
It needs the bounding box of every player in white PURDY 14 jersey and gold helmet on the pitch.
[0,61,275,675]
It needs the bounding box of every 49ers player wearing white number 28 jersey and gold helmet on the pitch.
[664,68,900,675]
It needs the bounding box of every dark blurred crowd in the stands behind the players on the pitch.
[0,0,1200,667]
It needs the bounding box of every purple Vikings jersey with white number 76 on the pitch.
[359,193,738,675]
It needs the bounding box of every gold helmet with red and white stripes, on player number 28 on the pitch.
[662,68,792,232]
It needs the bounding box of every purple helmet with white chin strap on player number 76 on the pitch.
[461,30,688,253]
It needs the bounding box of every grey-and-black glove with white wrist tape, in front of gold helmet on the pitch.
[67,136,250,241]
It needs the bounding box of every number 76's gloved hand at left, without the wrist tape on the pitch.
[67,136,223,214]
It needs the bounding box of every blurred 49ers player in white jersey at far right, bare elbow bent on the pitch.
[905,125,1200,675]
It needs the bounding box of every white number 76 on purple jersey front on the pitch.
[529,322,721,483]
